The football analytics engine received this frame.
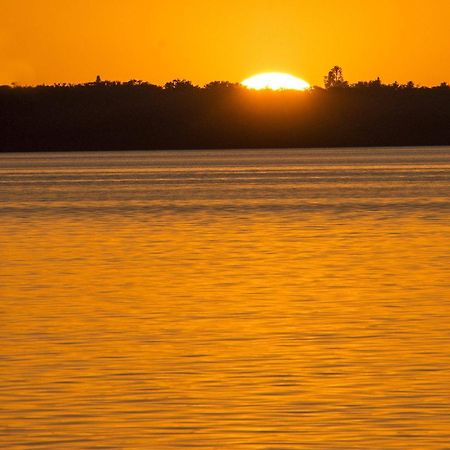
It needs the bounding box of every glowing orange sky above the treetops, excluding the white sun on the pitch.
[0,0,450,85]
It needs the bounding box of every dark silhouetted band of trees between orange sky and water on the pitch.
[0,75,450,151]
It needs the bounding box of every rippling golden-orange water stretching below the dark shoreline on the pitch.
[0,148,450,450]
